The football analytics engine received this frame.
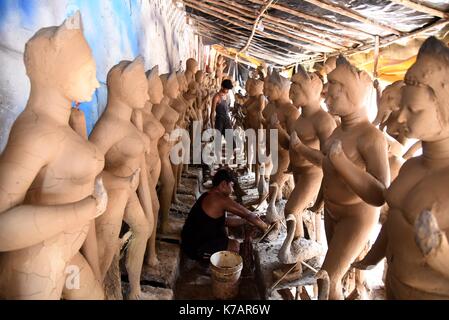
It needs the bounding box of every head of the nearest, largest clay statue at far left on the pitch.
[24,12,100,102]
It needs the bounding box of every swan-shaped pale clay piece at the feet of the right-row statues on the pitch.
[278,214,324,264]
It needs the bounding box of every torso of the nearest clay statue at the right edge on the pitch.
[386,157,449,299]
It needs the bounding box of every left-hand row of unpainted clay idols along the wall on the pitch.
[0,13,201,299]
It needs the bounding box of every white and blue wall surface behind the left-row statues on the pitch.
[0,0,194,150]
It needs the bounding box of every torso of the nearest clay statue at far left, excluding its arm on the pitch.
[0,111,104,299]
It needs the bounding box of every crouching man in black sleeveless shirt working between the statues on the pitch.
[181,169,268,260]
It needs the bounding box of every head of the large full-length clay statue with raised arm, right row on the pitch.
[326,56,372,116]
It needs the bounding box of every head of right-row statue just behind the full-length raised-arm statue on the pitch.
[290,66,323,107]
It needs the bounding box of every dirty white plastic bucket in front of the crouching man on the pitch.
[210,251,243,300]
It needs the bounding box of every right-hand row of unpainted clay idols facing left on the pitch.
[242,37,449,299]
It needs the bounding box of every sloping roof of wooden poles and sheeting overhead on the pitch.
[181,0,449,66]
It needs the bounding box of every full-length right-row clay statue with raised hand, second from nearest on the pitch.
[292,56,390,299]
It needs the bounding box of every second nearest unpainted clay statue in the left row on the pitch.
[89,58,154,299]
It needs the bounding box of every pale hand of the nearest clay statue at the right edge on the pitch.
[414,210,444,256]
